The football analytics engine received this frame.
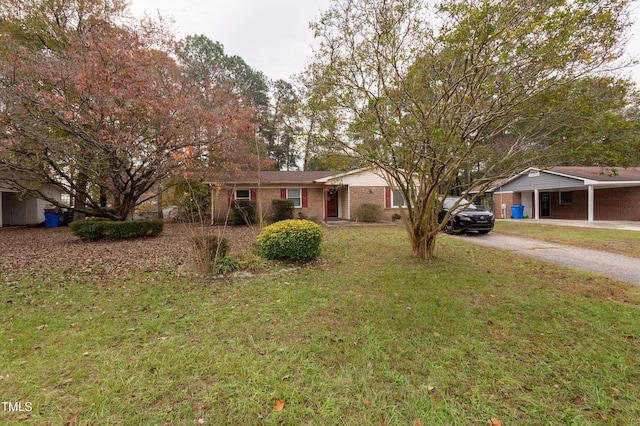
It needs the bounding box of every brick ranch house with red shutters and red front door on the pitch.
[208,167,410,223]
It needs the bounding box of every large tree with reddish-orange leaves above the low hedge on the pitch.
[0,0,255,220]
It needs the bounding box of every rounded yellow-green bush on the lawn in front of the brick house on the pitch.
[258,219,322,260]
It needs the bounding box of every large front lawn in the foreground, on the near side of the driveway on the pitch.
[0,227,640,425]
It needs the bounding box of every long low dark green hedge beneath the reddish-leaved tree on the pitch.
[69,219,164,241]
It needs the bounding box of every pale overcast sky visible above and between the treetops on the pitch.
[132,0,640,84]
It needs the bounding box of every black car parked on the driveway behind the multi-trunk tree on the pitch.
[438,197,495,234]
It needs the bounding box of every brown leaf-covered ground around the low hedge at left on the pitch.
[0,223,258,281]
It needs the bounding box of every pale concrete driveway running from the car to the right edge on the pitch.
[453,232,640,285]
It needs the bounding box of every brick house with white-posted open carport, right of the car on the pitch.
[491,167,640,222]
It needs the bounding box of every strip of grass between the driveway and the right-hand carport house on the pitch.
[495,220,640,258]
